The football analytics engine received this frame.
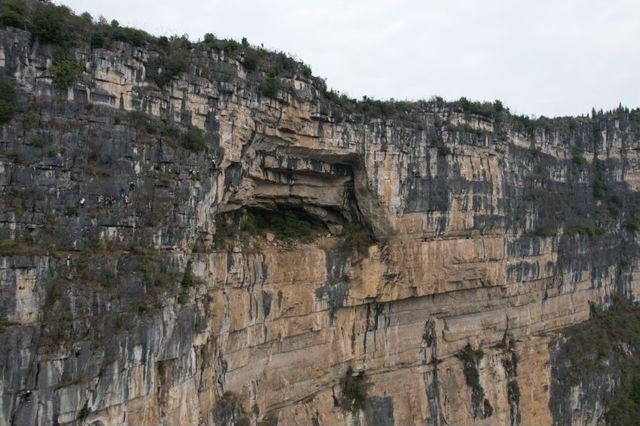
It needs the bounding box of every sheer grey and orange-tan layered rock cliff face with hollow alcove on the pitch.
[0,24,640,425]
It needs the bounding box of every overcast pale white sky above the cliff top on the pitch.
[59,0,640,116]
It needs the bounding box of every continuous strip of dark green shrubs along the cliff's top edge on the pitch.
[0,0,640,133]
